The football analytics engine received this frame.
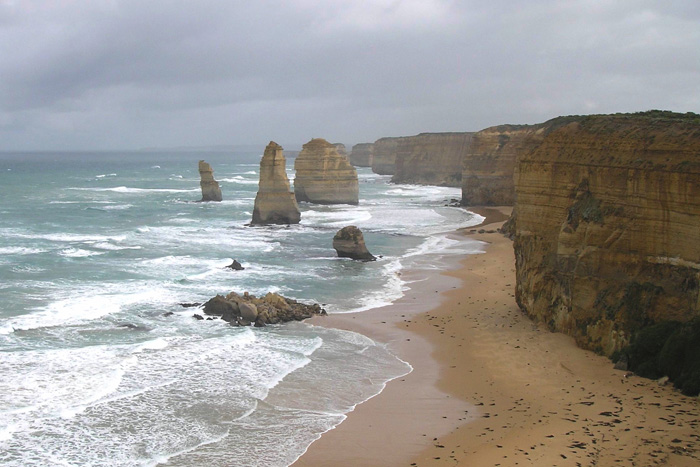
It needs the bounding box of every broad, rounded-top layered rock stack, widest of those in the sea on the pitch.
[294,138,360,204]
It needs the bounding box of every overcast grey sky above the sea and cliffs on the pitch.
[0,0,700,151]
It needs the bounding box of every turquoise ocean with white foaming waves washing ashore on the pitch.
[0,152,481,466]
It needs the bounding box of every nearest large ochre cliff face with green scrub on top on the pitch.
[514,111,700,355]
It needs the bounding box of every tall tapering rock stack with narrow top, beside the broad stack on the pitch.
[252,141,301,225]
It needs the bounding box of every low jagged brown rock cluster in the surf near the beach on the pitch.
[203,292,326,327]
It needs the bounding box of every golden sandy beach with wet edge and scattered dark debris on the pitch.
[294,208,700,466]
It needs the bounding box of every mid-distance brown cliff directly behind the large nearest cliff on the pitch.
[461,125,539,206]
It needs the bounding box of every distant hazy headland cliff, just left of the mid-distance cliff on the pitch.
[391,133,474,186]
